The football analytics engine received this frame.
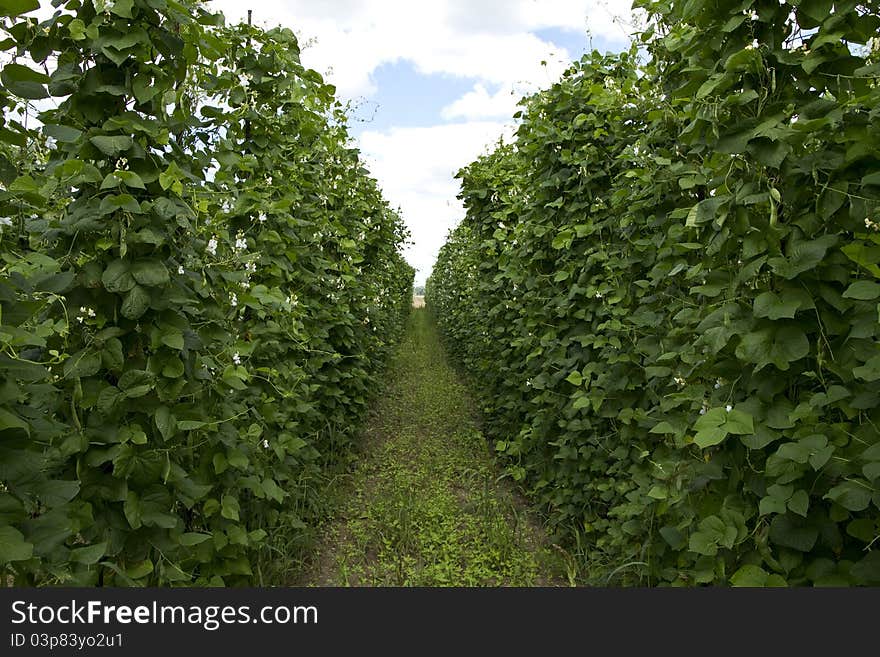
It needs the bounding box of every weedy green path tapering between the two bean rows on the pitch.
[297,308,562,586]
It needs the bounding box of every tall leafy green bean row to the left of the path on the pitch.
[0,0,413,586]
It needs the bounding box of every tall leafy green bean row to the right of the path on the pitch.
[428,0,880,586]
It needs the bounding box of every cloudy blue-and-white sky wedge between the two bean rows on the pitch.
[210,0,633,284]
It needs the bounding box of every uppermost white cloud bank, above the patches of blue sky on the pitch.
[209,0,630,98]
